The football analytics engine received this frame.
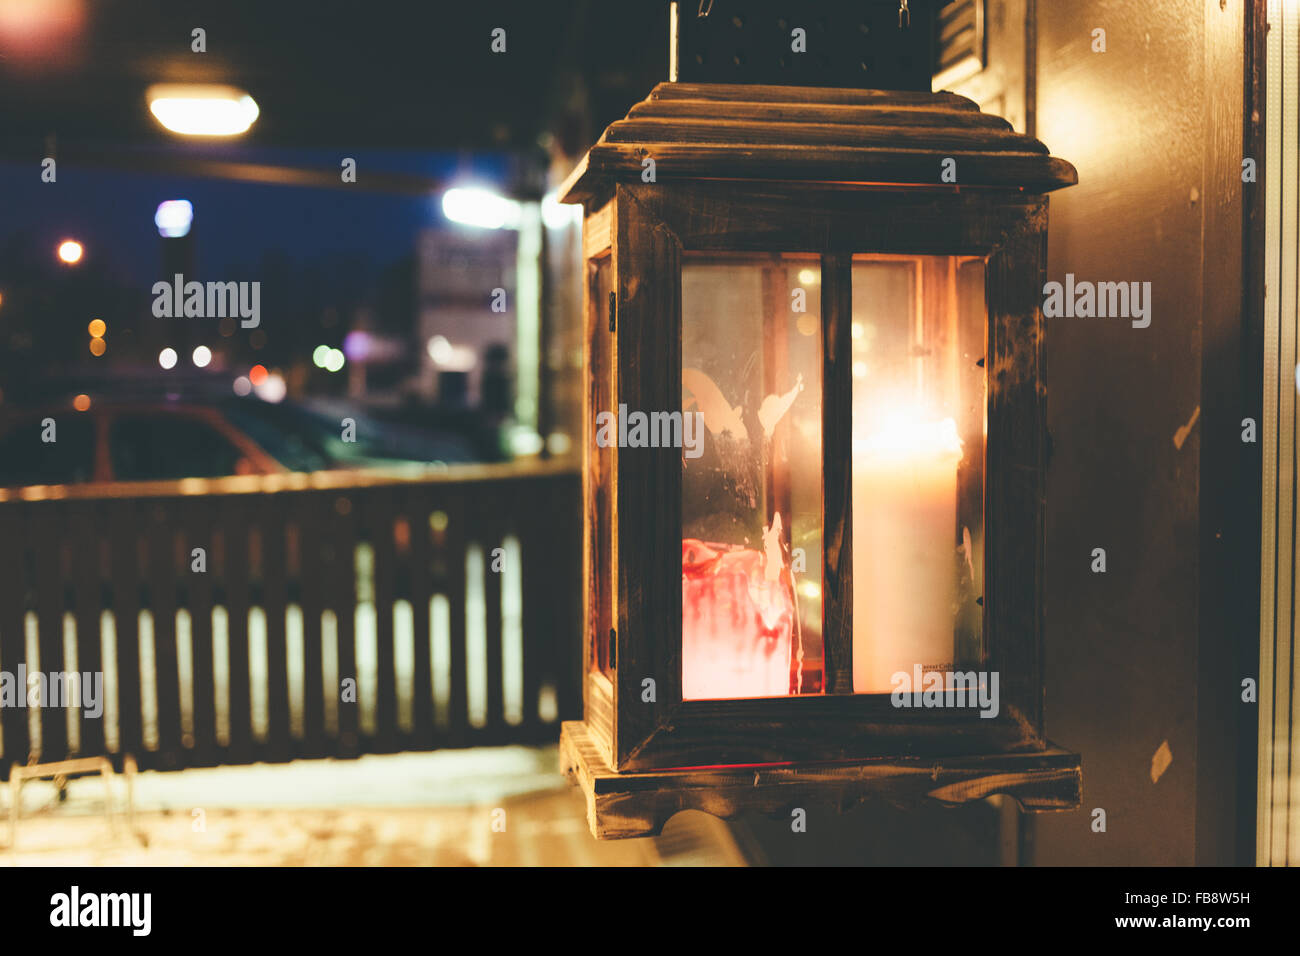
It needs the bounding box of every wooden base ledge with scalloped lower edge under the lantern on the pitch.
[560,721,1083,840]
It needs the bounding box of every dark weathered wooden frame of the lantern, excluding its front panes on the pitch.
[562,83,1082,836]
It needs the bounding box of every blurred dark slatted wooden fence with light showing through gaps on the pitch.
[0,466,581,773]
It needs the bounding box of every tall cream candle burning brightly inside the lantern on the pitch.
[853,419,962,693]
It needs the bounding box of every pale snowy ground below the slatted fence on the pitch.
[0,747,744,866]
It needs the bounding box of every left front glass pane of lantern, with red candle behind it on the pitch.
[681,255,823,700]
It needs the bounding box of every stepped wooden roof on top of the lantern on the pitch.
[560,83,1079,203]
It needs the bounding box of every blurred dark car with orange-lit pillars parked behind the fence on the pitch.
[0,398,475,488]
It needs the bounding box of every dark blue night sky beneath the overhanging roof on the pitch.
[0,147,504,291]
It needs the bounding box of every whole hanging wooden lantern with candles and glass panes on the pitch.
[560,83,1082,838]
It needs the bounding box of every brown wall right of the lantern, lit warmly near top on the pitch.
[1035,0,1258,865]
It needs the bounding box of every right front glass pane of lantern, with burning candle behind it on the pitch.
[852,256,987,693]
